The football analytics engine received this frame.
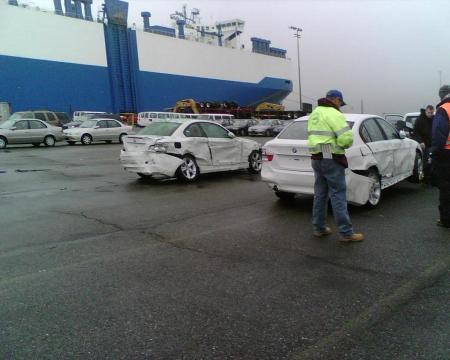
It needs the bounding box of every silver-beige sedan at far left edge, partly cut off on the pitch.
[0,119,64,149]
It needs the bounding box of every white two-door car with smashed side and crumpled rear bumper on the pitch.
[120,119,262,181]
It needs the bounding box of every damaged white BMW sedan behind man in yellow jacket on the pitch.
[261,114,423,206]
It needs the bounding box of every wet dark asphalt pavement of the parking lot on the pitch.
[0,139,450,360]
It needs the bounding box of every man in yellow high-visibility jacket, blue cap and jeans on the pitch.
[308,90,364,242]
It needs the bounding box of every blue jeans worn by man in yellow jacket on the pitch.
[311,159,353,236]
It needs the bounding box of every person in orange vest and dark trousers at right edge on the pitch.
[431,85,450,228]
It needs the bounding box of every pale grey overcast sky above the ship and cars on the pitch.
[33,0,450,114]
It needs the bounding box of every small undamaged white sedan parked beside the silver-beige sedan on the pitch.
[64,119,133,145]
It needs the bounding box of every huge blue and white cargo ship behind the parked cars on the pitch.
[0,0,292,113]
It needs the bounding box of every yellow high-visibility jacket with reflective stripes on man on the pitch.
[308,106,353,155]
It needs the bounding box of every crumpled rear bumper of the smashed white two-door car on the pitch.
[120,150,183,177]
